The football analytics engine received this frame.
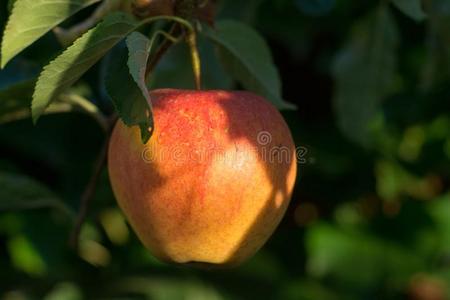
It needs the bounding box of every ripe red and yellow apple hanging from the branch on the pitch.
[108,89,297,267]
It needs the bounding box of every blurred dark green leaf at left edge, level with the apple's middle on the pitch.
[0,171,72,215]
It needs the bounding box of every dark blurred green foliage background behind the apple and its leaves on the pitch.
[0,0,450,300]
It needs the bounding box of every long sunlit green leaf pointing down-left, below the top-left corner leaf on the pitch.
[31,13,140,122]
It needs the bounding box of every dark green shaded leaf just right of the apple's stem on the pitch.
[203,21,295,109]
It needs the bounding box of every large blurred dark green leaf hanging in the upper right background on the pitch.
[333,6,398,146]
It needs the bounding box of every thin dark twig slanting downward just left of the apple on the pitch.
[69,116,117,249]
